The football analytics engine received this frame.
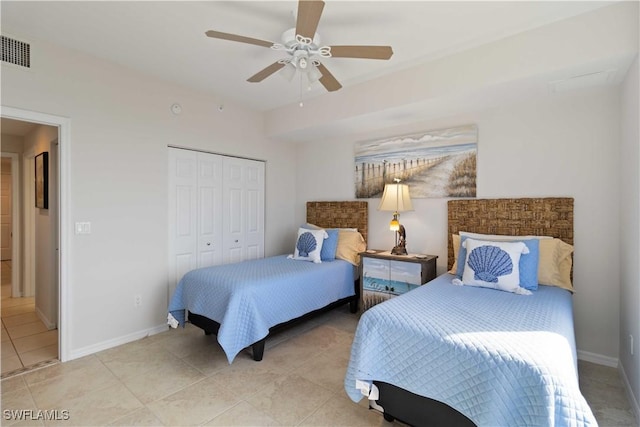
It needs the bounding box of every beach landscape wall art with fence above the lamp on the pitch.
[355,124,478,199]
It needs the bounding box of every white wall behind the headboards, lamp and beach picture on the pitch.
[296,87,620,363]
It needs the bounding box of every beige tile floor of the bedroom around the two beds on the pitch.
[1,307,637,427]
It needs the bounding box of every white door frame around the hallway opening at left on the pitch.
[0,105,73,362]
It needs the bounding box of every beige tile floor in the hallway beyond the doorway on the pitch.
[0,261,58,376]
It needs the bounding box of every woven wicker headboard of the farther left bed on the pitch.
[307,201,369,242]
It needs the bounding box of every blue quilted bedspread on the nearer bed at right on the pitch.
[345,274,597,426]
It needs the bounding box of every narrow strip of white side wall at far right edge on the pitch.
[619,58,640,419]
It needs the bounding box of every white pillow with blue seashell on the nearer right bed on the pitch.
[462,238,531,295]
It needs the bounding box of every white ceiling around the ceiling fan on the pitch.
[0,0,611,111]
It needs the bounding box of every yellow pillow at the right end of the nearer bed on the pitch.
[538,239,573,292]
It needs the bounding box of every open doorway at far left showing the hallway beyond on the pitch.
[0,118,59,376]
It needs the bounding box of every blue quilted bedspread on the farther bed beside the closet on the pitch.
[169,255,355,363]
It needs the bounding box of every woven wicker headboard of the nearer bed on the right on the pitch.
[447,197,573,269]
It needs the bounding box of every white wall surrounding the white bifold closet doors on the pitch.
[1,40,295,358]
